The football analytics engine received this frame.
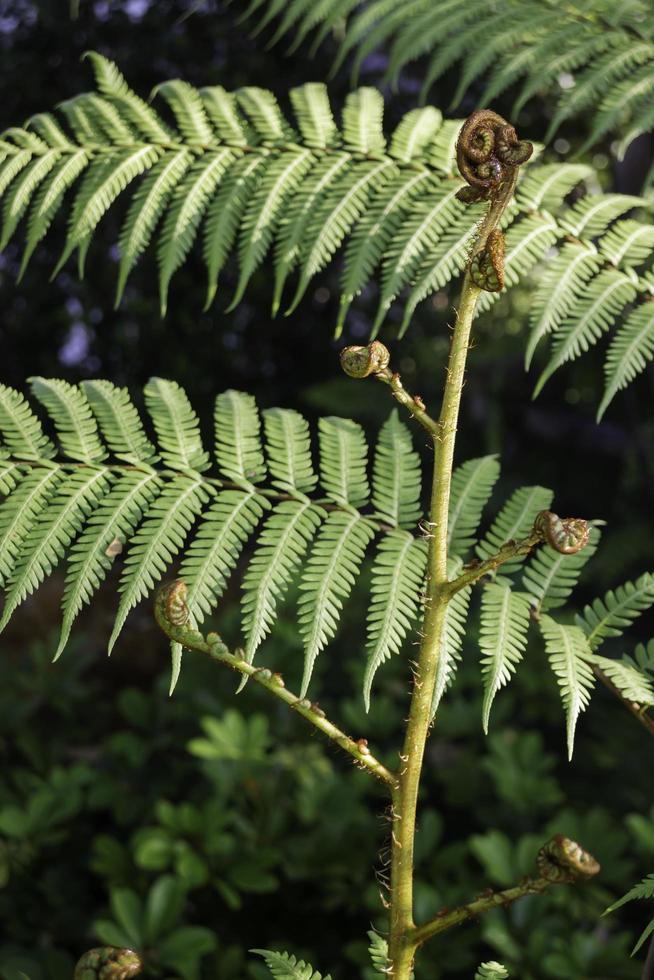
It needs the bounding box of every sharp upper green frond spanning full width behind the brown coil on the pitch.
[0,52,654,415]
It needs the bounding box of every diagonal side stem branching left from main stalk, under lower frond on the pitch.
[154,583,397,788]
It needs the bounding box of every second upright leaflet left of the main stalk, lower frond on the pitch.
[318,415,370,507]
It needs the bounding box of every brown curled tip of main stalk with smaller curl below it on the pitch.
[456,109,534,292]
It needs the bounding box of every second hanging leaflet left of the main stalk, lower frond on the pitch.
[298,511,375,698]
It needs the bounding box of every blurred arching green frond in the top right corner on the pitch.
[231,0,654,152]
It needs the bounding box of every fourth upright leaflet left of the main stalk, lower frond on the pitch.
[214,388,266,485]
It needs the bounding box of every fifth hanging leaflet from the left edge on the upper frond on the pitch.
[115,149,193,307]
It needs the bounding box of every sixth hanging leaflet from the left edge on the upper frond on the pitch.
[157,149,234,316]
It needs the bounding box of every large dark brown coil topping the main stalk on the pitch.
[456,109,534,197]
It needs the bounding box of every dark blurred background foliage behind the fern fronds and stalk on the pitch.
[0,0,654,980]
